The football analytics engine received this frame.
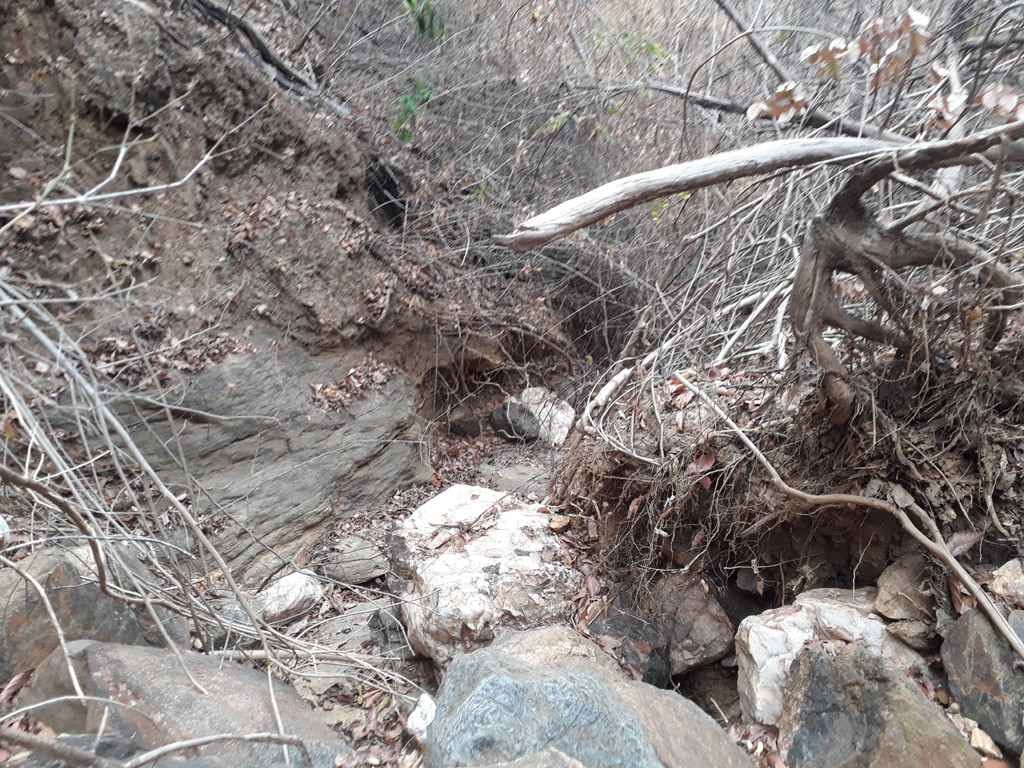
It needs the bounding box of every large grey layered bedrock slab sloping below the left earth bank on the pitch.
[117,328,430,584]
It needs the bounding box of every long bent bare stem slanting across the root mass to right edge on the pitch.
[678,377,1024,659]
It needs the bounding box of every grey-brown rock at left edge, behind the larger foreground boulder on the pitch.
[0,550,159,680]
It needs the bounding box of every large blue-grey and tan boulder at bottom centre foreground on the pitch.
[424,633,750,768]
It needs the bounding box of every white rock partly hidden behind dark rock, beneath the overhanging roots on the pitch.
[736,587,928,725]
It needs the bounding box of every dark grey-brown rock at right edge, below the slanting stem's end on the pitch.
[942,610,1024,754]
